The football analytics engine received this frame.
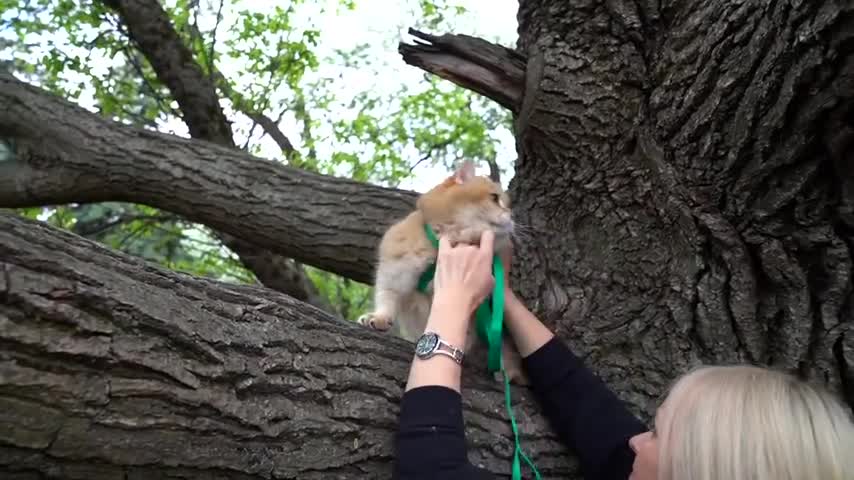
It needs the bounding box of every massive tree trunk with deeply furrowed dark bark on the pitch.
[502,0,854,418]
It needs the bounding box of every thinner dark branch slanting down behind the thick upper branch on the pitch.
[98,0,332,311]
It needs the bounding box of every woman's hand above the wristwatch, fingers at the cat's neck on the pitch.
[433,230,495,316]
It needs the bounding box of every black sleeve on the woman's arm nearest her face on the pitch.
[523,337,647,480]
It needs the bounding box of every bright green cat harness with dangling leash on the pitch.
[418,223,540,480]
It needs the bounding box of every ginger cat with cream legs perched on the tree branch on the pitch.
[358,161,528,385]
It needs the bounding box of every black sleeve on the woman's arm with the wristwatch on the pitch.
[393,386,495,480]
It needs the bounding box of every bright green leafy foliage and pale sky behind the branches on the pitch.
[0,0,509,319]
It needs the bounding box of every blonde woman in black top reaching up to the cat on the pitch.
[394,232,854,480]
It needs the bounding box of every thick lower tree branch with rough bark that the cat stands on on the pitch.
[0,214,574,480]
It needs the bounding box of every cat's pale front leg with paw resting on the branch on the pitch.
[358,255,430,331]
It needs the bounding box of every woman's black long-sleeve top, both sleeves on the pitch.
[394,337,647,480]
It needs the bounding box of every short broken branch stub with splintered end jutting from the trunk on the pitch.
[398,28,525,113]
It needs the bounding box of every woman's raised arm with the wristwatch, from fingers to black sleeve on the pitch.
[394,231,502,480]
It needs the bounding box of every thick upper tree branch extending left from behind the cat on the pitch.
[0,75,416,283]
